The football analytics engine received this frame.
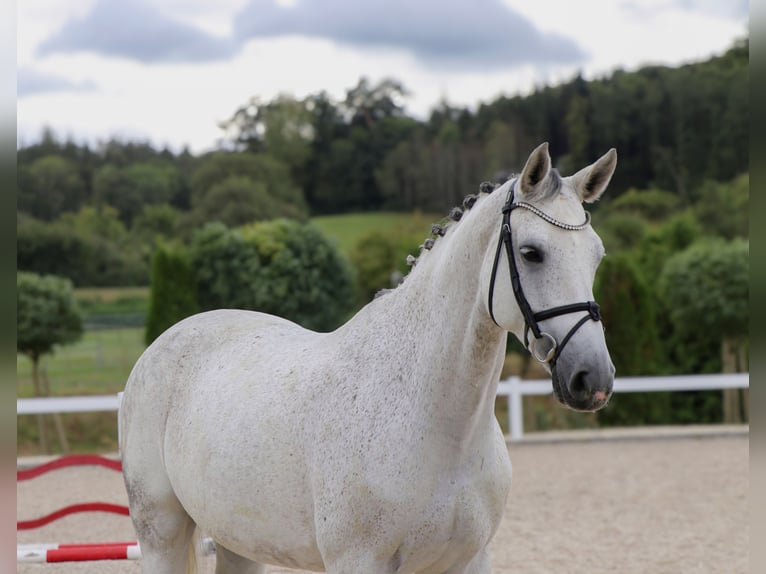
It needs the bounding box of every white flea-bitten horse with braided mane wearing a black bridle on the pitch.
[119,144,617,574]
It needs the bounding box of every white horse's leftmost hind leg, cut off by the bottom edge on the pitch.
[125,475,196,574]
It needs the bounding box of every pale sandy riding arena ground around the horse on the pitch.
[17,428,749,574]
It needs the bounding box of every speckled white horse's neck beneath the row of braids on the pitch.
[342,198,506,441]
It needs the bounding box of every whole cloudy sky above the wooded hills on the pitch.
[17,0,748,152]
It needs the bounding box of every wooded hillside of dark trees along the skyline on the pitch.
[18,39,749,286]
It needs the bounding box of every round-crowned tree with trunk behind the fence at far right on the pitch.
[660,240,750,422]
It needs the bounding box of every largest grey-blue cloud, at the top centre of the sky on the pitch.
[235,0,583,70]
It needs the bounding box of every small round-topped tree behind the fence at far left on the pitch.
[16,272,82,452]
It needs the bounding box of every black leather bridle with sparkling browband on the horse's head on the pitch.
[489,181,601,366]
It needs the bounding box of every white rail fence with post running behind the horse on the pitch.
[16,373,750,440]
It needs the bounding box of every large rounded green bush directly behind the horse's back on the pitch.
[191,219,353,331]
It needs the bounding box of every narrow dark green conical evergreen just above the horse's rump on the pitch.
[144,245,199,345]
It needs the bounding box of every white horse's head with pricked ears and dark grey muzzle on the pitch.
[482,143,617,411]
